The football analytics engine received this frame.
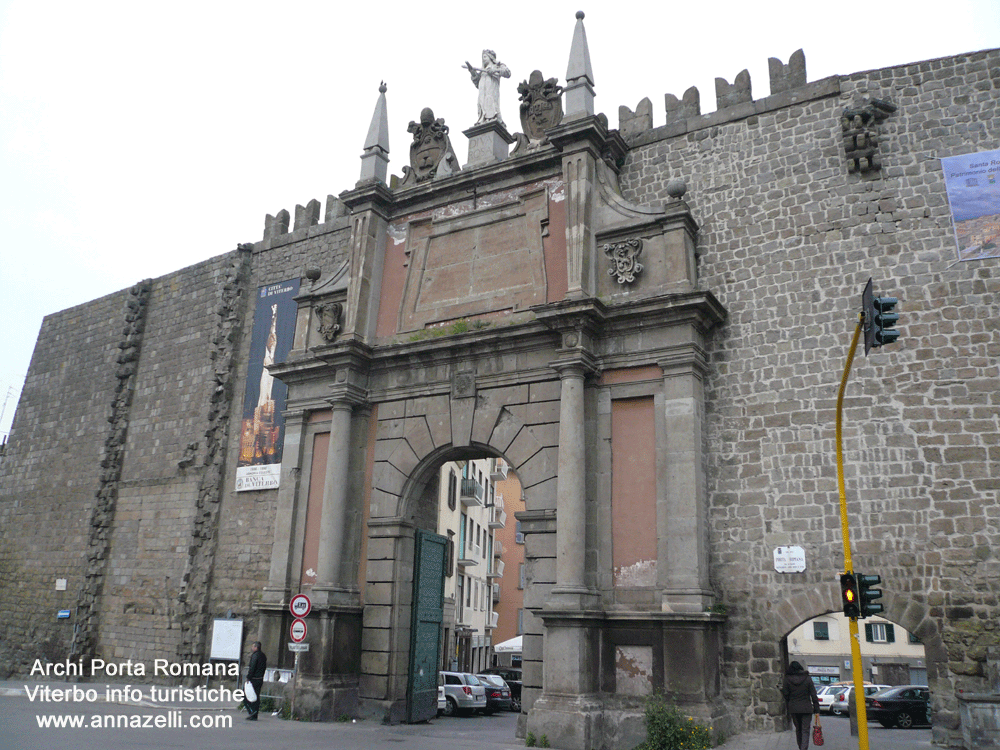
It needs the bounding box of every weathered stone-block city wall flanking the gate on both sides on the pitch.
[0,42,1000,740]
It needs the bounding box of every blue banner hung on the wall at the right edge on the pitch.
[941,151,1000,260]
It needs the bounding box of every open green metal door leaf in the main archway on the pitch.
[406,529,448,723]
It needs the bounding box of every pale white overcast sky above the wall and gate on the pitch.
[0,0,1000,436]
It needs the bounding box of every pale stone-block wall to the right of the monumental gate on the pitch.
[622,50,1000,732]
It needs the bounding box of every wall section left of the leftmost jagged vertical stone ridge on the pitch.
[0,290,129,675]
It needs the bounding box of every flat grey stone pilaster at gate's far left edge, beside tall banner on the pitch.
[264,410,309,605]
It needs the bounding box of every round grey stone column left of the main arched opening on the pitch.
[313,386,359,604]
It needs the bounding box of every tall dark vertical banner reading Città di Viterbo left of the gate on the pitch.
[236,279,299,492]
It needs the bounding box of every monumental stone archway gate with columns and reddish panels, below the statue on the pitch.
[262,111,725,748]
